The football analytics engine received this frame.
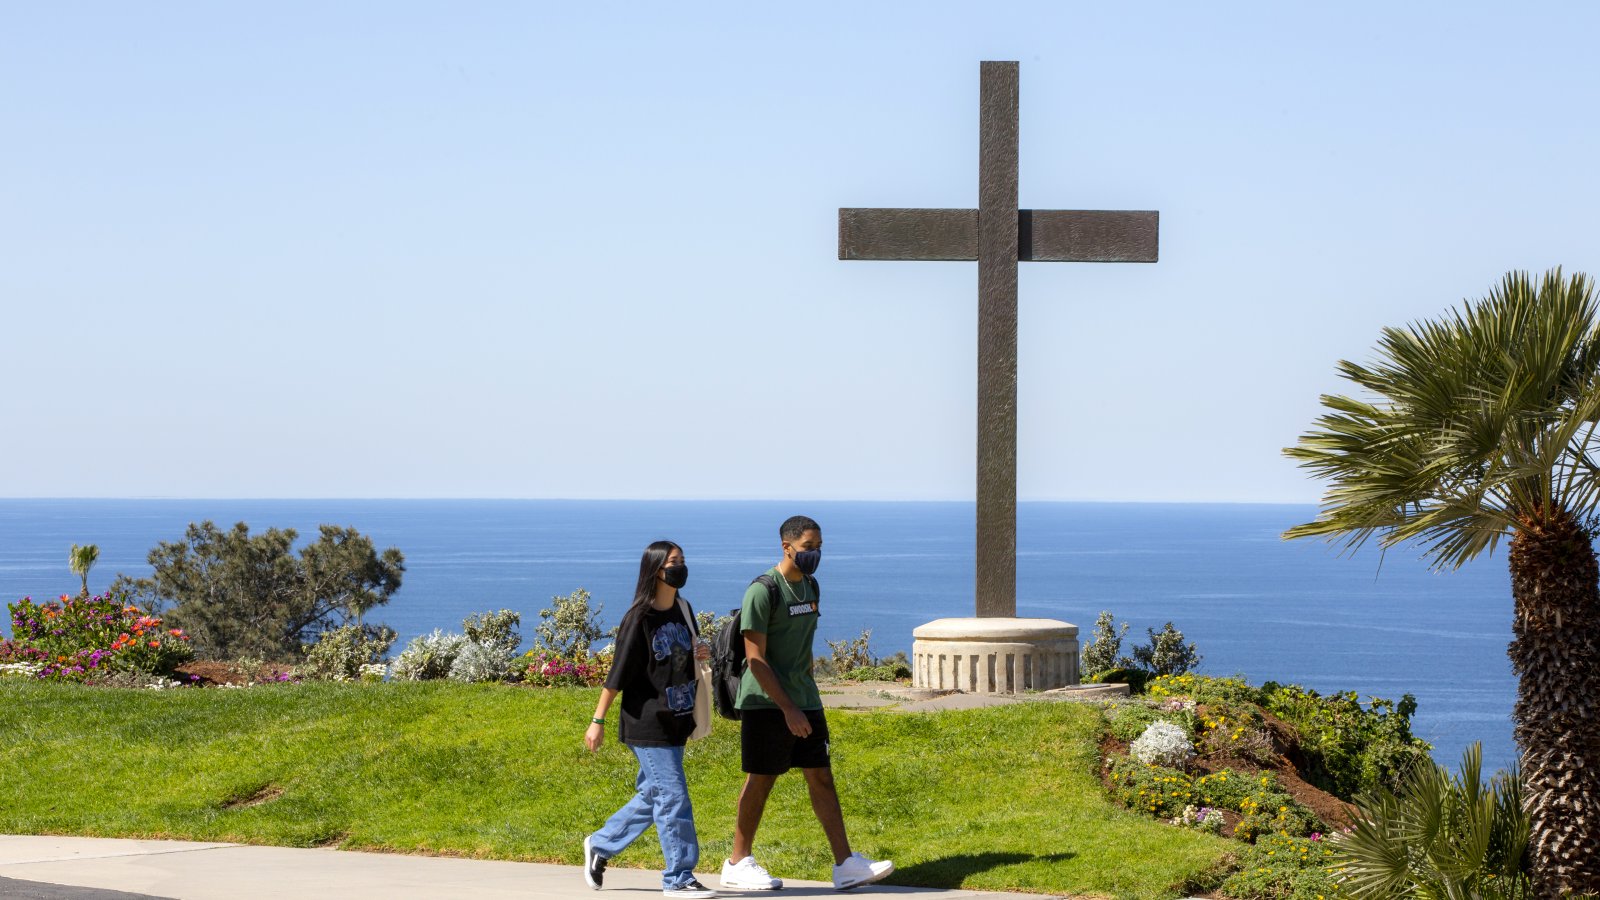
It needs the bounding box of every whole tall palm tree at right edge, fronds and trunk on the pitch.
[1285,269,1600,897]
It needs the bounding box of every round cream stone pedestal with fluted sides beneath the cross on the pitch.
[910,618,1078,693]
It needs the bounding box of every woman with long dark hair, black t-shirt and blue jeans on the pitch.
[584,541,717,897]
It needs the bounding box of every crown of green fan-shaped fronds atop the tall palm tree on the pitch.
[1285,269,1600,569]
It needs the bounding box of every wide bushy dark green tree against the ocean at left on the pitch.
[114,522,405,660]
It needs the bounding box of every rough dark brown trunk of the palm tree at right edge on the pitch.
[1510,511,1600,898]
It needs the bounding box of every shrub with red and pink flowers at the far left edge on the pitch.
[6,593,194,681]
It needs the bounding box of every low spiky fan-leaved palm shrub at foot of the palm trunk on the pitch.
[1333,745,1531,898]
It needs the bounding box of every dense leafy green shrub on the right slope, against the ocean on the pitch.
[1261,682,1432,799]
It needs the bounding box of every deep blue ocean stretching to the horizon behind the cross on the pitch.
[0,500,1515,769]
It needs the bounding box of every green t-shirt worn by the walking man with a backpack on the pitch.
[734,569,822,709]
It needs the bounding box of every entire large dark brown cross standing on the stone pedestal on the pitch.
[838,62,1158,617]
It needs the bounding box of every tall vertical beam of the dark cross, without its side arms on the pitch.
[976,62,1019,617]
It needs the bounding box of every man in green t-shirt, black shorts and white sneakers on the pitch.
[722,516,894,890]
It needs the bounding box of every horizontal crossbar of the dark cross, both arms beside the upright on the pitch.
[838,208,1160,263]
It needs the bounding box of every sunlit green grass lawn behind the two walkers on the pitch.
[0,679,1230,898]
